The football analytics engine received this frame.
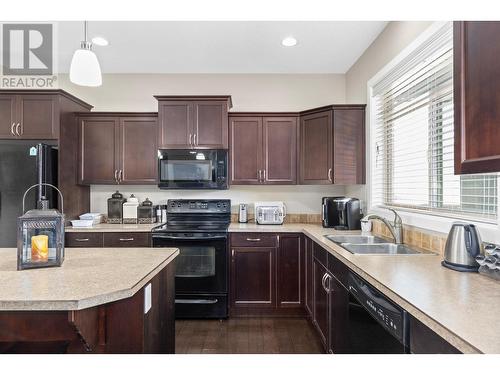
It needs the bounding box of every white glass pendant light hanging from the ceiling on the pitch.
[69,21,102,87]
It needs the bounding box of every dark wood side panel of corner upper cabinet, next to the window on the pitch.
[332,109,365,185]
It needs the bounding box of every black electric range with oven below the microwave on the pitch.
[152,199,231,319]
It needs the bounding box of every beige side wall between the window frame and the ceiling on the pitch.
[346,21,432,201]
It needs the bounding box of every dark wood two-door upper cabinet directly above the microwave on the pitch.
[155,96,232,149]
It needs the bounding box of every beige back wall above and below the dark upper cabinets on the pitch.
[59,74,345,213]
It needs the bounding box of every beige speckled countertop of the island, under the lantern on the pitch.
[0,248,179,311]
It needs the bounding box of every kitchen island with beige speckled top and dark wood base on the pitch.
[0,248,179,353]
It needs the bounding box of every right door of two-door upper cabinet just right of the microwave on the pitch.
[262,117,297,185]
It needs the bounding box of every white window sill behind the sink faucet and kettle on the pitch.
[368,206,500,244]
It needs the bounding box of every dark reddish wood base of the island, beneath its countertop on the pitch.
[0,262,175,354]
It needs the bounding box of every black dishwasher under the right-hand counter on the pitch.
[346,273,409,354]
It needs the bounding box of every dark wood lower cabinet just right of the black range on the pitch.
[230,233,305,316]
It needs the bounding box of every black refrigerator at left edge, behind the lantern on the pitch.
[0,140,58,248]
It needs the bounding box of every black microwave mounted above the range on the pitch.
[158,149,228,190]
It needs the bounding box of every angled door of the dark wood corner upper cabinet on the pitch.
[300,110,332,184]
